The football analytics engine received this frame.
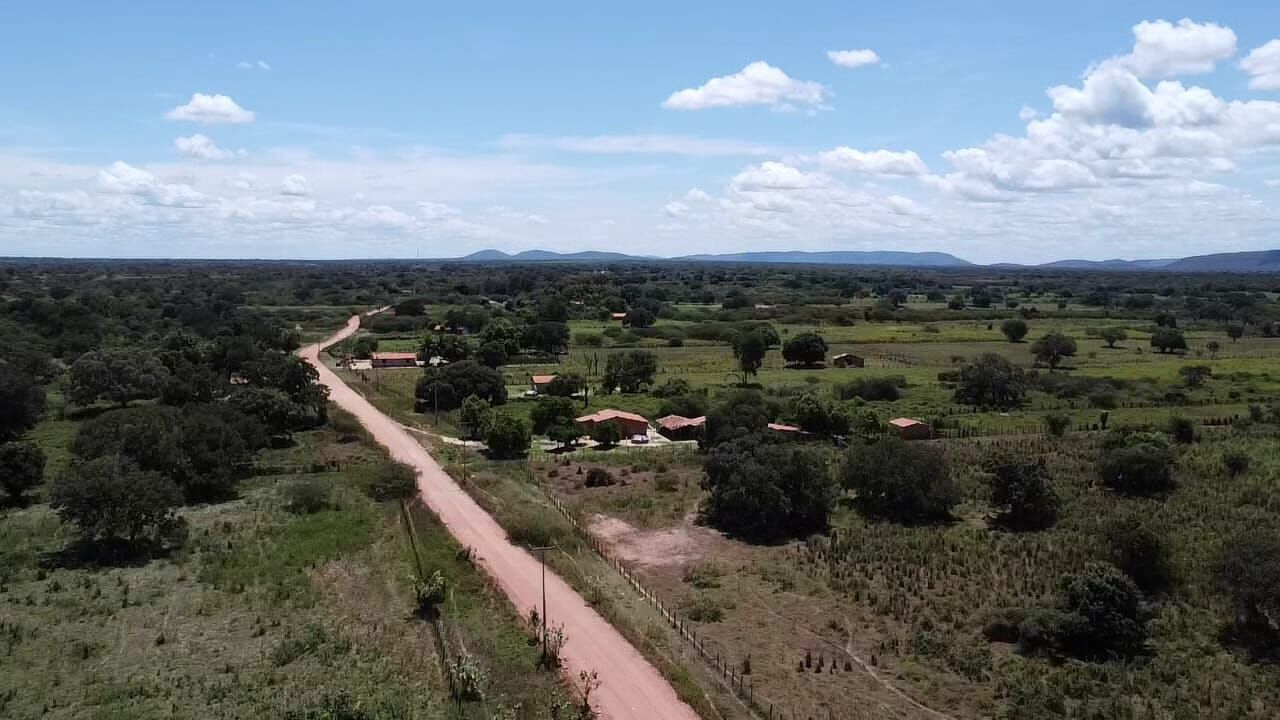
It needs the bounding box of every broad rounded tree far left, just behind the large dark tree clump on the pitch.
[67,348,169,406]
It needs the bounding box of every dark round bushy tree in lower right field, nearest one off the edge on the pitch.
[1059,562,1151,659]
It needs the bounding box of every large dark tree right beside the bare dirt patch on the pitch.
[701,434,836,542]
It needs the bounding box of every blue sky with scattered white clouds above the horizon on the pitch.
[0,1,1280,261]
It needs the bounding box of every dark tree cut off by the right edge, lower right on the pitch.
[1215,529,1280,661]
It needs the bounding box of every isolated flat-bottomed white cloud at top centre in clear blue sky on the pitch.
[662,60,828,110]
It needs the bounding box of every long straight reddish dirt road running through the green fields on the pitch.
[298,316,698,720]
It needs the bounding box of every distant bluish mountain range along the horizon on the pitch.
[456,250,1280,273]
